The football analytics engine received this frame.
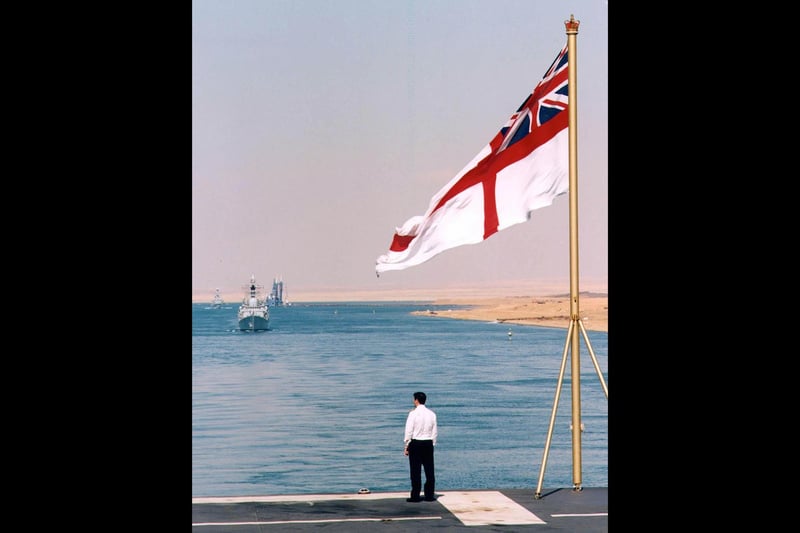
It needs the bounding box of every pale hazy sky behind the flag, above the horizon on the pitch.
[192,0,608,301]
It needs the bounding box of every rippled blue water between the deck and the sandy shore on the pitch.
[192,302,608,497]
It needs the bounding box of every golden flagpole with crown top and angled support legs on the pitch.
[534,15,608,499]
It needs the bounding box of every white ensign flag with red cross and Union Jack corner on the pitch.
[375,45,569,274]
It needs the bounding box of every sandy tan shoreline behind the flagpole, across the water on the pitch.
[413,292,608,332]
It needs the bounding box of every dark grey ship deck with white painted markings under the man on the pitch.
[192,487,608,533]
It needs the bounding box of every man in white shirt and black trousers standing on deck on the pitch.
[404,392,438,502]
